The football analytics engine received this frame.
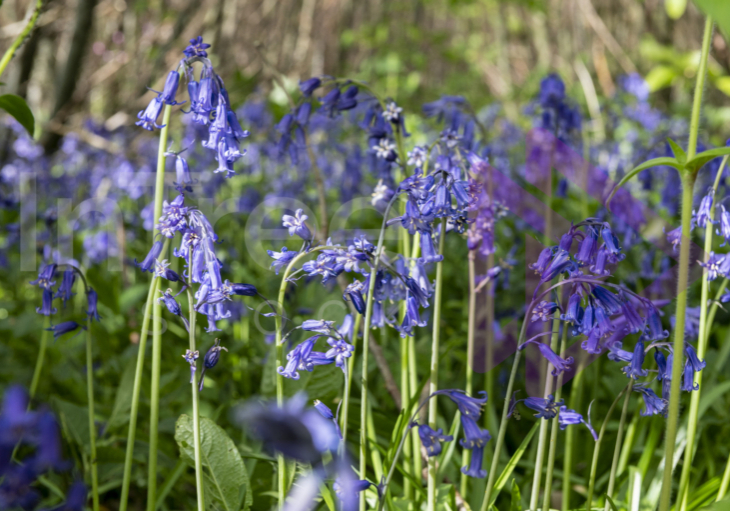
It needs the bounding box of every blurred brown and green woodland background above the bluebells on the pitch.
[0,0,730,149]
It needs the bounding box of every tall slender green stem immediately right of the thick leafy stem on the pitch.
[677,156,728,511]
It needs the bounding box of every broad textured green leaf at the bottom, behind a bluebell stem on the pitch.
[175,414,253,511]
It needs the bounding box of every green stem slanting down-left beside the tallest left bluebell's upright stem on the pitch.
[119,253,170,511]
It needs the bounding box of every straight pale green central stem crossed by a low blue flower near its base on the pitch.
[427,220,446,511]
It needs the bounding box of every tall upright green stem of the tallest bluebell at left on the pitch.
[147,105,172,511]
